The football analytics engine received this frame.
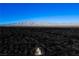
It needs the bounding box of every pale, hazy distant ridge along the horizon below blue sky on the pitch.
[0,21,79,26]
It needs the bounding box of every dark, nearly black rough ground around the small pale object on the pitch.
[0,27,79,56]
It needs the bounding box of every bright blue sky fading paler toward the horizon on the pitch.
[0,3,79,24]
